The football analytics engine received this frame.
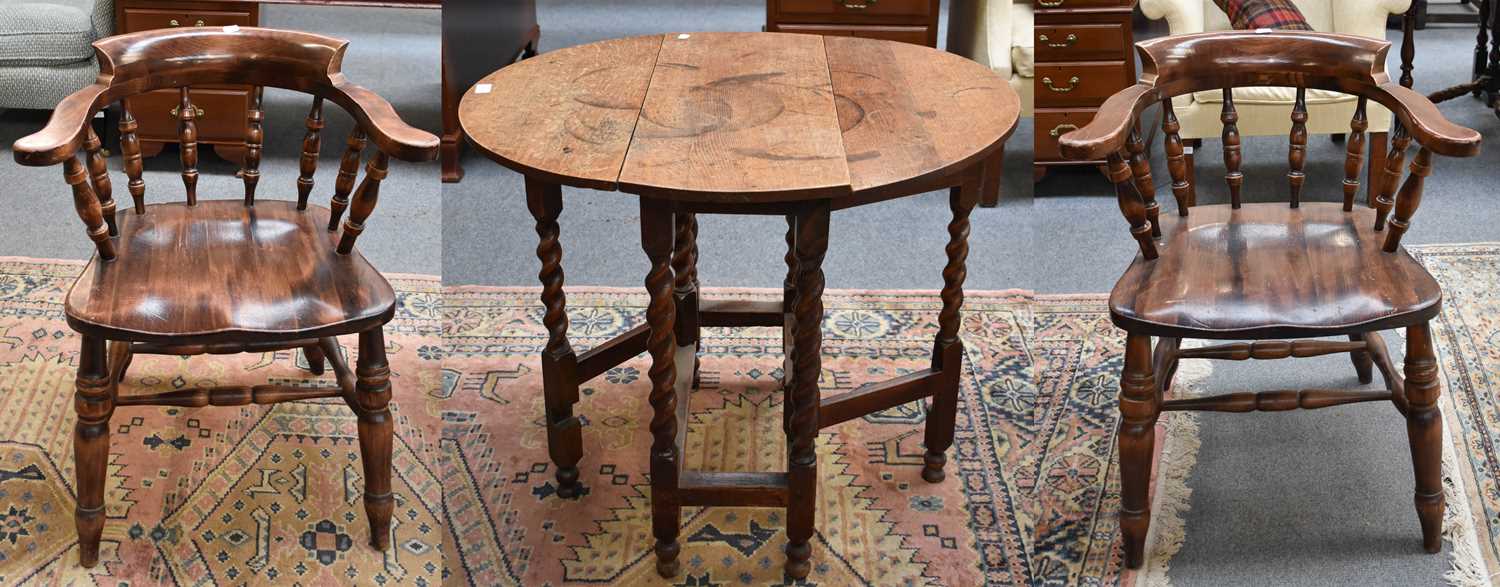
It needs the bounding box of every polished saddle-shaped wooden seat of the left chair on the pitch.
[66,200,396,344]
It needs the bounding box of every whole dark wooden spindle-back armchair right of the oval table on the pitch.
[1061,32,1479,567]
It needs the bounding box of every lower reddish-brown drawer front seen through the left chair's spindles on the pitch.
[128,89,251,143]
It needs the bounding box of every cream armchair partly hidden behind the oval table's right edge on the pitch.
[948,0,1035,206]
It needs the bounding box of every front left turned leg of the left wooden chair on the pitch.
[74,335,116,567]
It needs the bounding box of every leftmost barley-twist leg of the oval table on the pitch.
[527,177,584,498]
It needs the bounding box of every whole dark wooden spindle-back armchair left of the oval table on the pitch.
[15,27,438,566]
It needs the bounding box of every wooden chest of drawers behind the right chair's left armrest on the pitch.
[1034,0,1136,180]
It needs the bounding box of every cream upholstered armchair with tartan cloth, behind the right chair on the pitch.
[1140,0,1412,201]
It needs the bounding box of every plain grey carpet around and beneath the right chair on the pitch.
[1031,20,1500,585]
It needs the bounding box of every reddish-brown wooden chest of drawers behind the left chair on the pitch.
[114,0,443,162]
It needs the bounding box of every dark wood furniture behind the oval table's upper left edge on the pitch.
[441,0,542,183]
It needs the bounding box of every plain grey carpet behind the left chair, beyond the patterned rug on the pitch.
[0,5,443,275]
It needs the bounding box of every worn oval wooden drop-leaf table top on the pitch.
[459,33,1020,204]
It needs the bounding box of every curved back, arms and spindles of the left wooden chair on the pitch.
[15,27,438,261]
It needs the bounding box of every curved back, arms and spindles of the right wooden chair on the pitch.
[1058,32,1481,260]
